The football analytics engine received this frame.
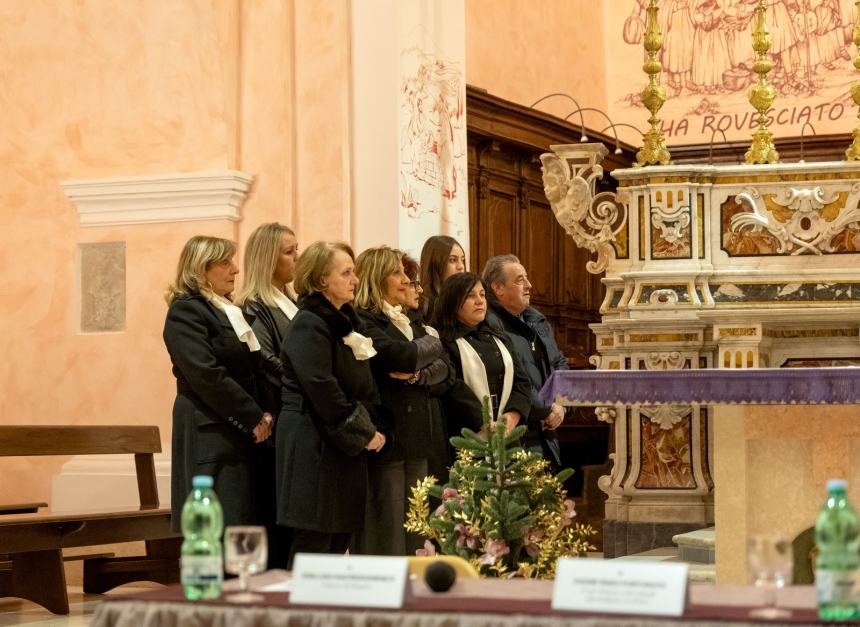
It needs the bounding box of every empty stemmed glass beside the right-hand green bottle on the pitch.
[747,535,794,620]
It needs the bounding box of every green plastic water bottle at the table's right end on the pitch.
[815,479,860,620]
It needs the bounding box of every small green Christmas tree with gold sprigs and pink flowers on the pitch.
[405,397,595,579]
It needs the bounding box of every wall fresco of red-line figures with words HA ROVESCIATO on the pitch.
[605,0,860,146]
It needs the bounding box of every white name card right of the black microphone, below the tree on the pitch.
[552,559,687,616]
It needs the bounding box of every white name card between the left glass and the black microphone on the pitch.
[290,553,409,608]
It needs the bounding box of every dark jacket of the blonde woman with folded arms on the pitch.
[358,309,454,466]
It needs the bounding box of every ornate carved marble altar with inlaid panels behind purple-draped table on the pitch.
[541,145,860,548]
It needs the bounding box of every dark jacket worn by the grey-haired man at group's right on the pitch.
[490,298,568,465]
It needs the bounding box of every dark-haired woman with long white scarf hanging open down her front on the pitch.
[433,272,531,440]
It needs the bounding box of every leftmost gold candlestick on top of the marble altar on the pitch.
[634,0,672,166]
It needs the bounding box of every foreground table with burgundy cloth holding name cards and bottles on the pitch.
[90,571,818,627]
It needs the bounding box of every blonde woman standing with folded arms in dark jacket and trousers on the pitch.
[353,246,453,555]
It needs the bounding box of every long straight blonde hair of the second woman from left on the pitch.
[236,222,296,307]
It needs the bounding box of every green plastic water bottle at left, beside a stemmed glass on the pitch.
[180,475,224,601]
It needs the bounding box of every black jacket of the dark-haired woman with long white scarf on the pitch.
[442,321,531,435]
